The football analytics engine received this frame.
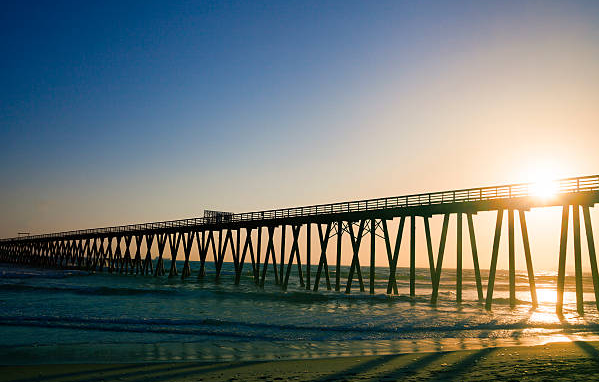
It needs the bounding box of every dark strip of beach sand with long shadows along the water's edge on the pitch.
[0,341,599,382]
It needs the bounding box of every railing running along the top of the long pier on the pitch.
[0,175,599,241]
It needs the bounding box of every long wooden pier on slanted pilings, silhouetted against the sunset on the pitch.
[0,175,599,314]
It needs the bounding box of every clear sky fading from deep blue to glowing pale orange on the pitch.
[0,0,599,270]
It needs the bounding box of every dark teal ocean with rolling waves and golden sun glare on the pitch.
[0,261,599,364]
